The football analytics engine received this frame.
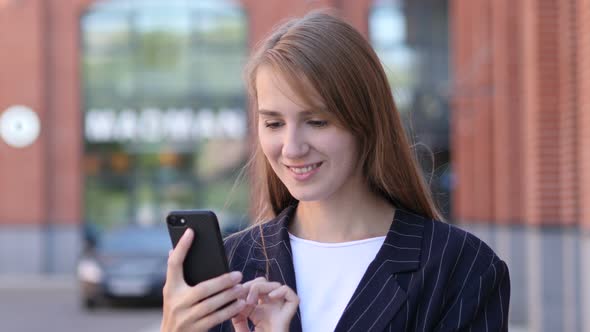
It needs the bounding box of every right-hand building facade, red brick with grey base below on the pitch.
[450,0,590,331]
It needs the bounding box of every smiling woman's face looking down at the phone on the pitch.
[255,66,361,201]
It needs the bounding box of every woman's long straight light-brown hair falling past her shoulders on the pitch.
[245,10,443,224]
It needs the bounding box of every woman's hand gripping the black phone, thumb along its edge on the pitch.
[160,229,248,332]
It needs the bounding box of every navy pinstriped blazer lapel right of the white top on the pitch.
[335,208,424,332]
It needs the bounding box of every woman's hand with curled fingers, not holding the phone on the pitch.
[232,278,299,332]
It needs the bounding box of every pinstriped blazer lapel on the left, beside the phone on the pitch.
[253,205,301,332]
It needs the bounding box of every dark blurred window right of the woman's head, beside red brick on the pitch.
[369,0,452,217]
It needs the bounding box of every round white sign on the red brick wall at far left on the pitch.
[0,105,41,148]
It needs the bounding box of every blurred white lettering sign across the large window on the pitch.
[85,108,247,143]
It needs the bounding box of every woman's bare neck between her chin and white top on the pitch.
[289,188,395,242]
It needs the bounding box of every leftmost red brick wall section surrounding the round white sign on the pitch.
[0,1,48,224]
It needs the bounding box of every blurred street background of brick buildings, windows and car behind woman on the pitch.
[0,0,590,332]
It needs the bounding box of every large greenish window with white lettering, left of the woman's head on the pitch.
[80,0,248,232]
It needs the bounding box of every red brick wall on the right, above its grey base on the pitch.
[451,0,590,225]
